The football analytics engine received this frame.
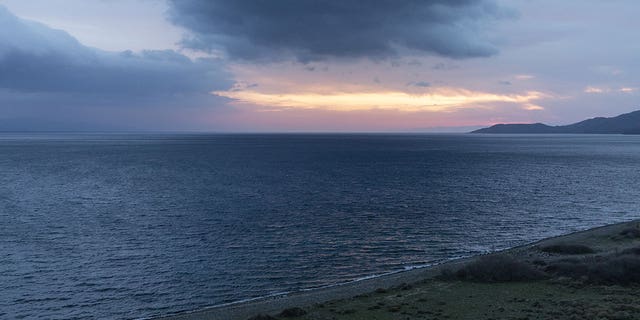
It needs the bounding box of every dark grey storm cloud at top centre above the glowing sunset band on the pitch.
[169,0,508,61]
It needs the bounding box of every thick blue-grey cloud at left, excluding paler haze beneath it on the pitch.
[0,6,230,98]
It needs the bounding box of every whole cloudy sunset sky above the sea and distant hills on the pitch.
[0,0,640,132]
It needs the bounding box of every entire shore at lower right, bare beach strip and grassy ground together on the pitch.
[158,220,640,320]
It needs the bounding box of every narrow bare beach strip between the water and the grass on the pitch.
[151,219,640,320]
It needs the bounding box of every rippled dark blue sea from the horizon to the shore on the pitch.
[0,134,640,319]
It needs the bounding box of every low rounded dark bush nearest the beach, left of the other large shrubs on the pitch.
[443,255,546,282]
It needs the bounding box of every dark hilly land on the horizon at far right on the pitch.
[471,110,640,134]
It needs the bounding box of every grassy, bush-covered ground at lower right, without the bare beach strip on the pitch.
[240,224,640,320]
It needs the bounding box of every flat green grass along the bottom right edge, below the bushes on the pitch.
[268,280,640,320]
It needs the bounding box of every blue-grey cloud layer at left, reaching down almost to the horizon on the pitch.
[0,5,233,129]
